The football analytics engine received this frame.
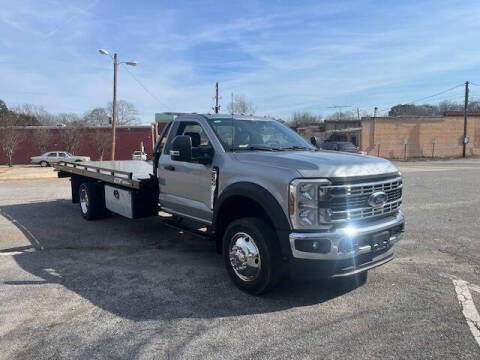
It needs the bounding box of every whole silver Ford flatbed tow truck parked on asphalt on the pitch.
[55,114,404,294]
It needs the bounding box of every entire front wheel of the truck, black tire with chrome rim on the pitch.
[223,218,283,295]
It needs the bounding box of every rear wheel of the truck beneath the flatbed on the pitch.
[78,182,106,220]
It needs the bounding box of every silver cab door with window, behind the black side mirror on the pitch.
[157,120,213,224]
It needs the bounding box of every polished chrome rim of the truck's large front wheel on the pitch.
[229,232,262,282]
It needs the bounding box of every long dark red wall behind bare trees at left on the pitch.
[0,126,165,164]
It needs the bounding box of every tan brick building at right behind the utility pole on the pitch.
[361,111,480,159]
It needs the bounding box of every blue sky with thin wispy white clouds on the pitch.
[0,0,480,123]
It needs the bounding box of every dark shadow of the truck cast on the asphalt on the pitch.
[0,200,366,321]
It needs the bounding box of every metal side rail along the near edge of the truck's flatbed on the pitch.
[53,161,144,189]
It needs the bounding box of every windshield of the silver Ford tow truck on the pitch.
[209,119,314,151]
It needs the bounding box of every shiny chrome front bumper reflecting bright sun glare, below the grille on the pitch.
[289,212,405,261]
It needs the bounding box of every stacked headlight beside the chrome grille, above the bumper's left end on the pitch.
[288,179,331,229]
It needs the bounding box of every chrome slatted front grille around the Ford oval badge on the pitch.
[320,177,403,222]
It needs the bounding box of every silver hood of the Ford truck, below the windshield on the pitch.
[234,151,398,178]
